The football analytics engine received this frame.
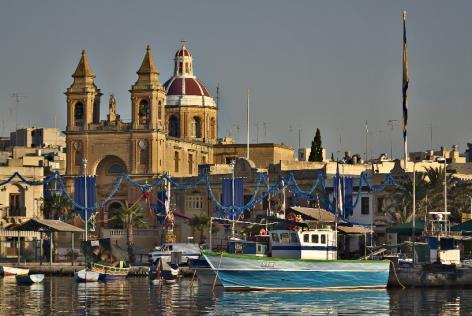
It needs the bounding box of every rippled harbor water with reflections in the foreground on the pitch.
[0,277,472,316]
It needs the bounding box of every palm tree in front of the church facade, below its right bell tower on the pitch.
[111,203,148,262]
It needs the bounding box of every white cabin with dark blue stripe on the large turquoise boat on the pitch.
[269,229,337,260]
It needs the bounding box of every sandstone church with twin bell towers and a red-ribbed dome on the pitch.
[65,45,293,227]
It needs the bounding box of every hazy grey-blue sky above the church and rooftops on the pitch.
[0,0,472,156]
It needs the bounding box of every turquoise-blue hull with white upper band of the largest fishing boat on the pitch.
[205,254,390,290]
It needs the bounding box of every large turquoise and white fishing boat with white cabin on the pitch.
[203,228,390,290]
